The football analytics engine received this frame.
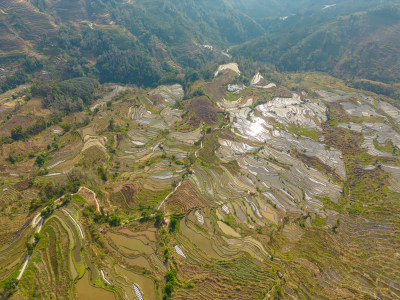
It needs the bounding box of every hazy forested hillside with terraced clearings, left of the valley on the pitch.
[0,0,264,90]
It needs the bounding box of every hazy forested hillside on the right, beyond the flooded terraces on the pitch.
[232,6,400,82]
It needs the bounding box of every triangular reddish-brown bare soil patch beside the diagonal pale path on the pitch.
[166,180,212,213]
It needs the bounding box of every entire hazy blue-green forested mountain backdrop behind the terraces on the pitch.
[0,0,400,94]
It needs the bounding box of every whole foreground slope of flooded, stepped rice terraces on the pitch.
[0,63,400,299]
